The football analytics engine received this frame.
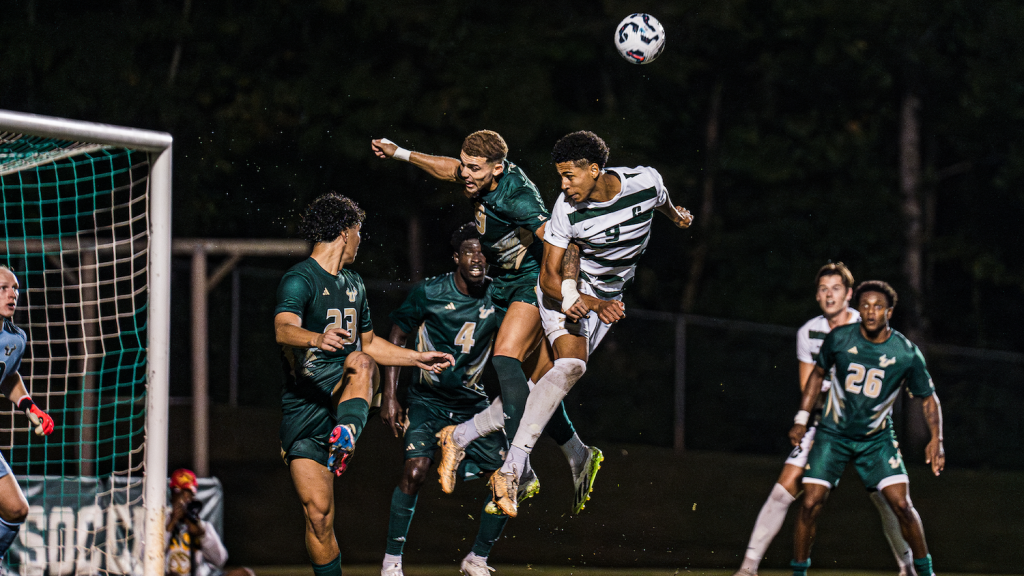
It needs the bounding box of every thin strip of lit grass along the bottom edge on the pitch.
[254,564,1009,576]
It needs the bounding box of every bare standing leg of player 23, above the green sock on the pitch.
[288,458,341,574]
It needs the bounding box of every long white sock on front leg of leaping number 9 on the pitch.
[502,358,587,475]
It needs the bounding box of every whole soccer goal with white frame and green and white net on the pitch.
[0,110,173,576]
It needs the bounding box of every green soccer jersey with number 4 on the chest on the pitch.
[391,273,499,408]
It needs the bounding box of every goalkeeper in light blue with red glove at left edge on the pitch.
[0,264,53,559]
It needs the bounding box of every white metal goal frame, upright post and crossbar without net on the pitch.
[0,110,174,576]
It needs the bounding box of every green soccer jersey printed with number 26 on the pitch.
[818,324,935,440]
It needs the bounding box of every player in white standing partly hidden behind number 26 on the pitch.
[734,262,913,576]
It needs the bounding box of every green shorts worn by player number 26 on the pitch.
[804,426,910,490]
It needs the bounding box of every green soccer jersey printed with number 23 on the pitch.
[273,257,374,401]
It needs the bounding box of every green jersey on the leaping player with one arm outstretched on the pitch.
[473,160,551,279]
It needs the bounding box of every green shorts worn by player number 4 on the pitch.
[404,401,508,480]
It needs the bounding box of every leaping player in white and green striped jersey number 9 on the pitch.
[490,131,693,517]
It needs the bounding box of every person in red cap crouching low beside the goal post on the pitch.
[164,468,255,576]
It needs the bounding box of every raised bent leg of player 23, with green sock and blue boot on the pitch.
[327,352,380,476]
